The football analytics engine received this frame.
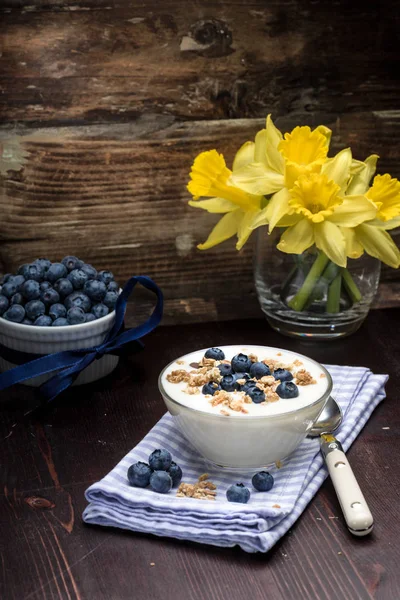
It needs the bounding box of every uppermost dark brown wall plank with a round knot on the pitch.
[0,0,400,123]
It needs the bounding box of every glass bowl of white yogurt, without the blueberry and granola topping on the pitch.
[159,345,332,469]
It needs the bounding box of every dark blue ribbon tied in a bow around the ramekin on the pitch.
[0,275,163,401]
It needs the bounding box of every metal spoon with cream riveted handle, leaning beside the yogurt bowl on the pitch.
[308,397,374,536]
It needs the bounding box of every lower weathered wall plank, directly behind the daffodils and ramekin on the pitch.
[0,112,400,323]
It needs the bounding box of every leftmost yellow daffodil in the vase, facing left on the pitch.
[187,152,263,250]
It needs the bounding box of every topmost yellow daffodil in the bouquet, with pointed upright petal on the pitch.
[232,115,331,195]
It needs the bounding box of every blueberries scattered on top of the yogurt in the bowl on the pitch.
[202,348,299,404]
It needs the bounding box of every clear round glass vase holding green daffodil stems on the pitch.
[254,227,380,340]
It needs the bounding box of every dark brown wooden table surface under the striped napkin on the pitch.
[0,310,400,600]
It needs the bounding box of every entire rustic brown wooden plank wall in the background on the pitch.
[0,0,400,322]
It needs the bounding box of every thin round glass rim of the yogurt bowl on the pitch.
[158,344,333,421]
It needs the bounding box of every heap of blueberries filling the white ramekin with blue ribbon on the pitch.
[0,256,119,327]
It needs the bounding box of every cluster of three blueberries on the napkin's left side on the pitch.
[128,449,182,494]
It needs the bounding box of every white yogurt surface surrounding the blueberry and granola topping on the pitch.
[162,346,329,419]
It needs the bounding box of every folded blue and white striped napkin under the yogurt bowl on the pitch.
[83,366,388,552]
